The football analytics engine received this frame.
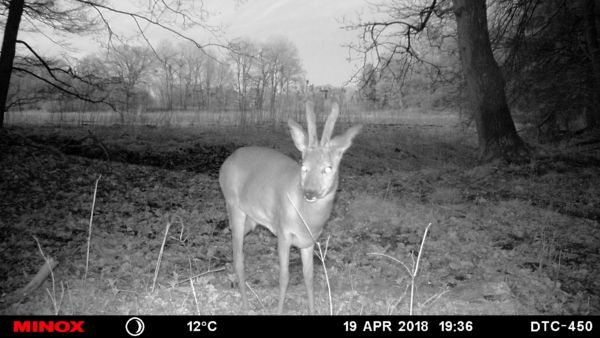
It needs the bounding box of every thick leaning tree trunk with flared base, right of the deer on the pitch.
[453,0,529,162]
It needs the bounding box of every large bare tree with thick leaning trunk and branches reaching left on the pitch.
[349,0,527,161]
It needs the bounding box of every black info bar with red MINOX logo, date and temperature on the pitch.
[0,315,600,338]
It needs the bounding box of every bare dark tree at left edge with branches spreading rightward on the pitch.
[0,0,226,127]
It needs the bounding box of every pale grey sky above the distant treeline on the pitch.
[20,0,367,86]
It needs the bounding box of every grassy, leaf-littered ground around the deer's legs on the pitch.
[0,112,600,315]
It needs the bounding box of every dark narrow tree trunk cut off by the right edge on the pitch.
[583,0,600,127]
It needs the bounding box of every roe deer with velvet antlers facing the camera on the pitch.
[219,103,361,314]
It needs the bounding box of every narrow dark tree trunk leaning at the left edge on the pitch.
[0,0,25,128]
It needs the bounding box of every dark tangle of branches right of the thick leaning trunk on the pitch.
[488,0,600,136]
